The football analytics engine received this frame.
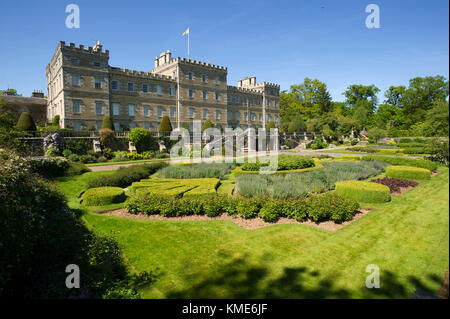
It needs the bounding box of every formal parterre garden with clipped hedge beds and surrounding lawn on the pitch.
[52,151,448,298]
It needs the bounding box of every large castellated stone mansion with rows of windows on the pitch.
[46,41,280,131]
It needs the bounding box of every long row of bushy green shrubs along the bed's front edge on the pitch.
[126,192,359,223]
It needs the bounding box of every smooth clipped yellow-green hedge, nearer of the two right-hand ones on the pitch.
[336,181,391,203]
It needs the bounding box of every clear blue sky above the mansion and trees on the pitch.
[0,0,449,101]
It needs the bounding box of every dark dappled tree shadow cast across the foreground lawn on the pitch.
[167,256,442,299]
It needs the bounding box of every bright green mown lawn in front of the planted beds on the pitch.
[59,168,449,298]
